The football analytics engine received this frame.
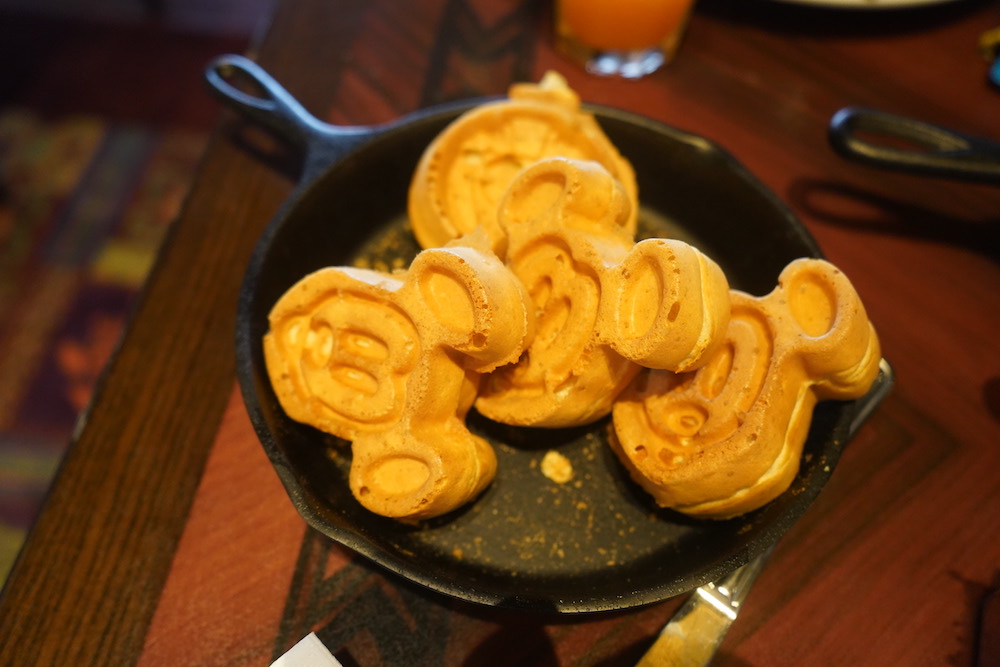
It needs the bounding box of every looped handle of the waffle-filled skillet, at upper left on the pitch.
[205,54,376,176]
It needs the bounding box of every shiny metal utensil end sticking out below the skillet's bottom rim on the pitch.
[636,547,773,667]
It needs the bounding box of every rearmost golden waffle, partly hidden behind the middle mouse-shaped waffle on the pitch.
[408,72,638,257]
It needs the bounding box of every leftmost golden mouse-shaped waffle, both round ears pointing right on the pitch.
[264,235,532,519]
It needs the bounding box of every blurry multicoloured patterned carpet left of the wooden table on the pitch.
[0,108,207,581]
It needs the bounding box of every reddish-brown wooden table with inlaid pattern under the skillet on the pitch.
[0,0,1000,667]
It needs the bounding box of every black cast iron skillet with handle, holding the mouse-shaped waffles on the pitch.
[206,56,892,613]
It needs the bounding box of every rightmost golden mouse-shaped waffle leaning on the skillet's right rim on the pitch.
[611,259,881,519]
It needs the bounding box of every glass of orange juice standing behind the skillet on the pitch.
[555,0,695,79]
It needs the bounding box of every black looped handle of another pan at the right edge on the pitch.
[828,107,1000,185]
